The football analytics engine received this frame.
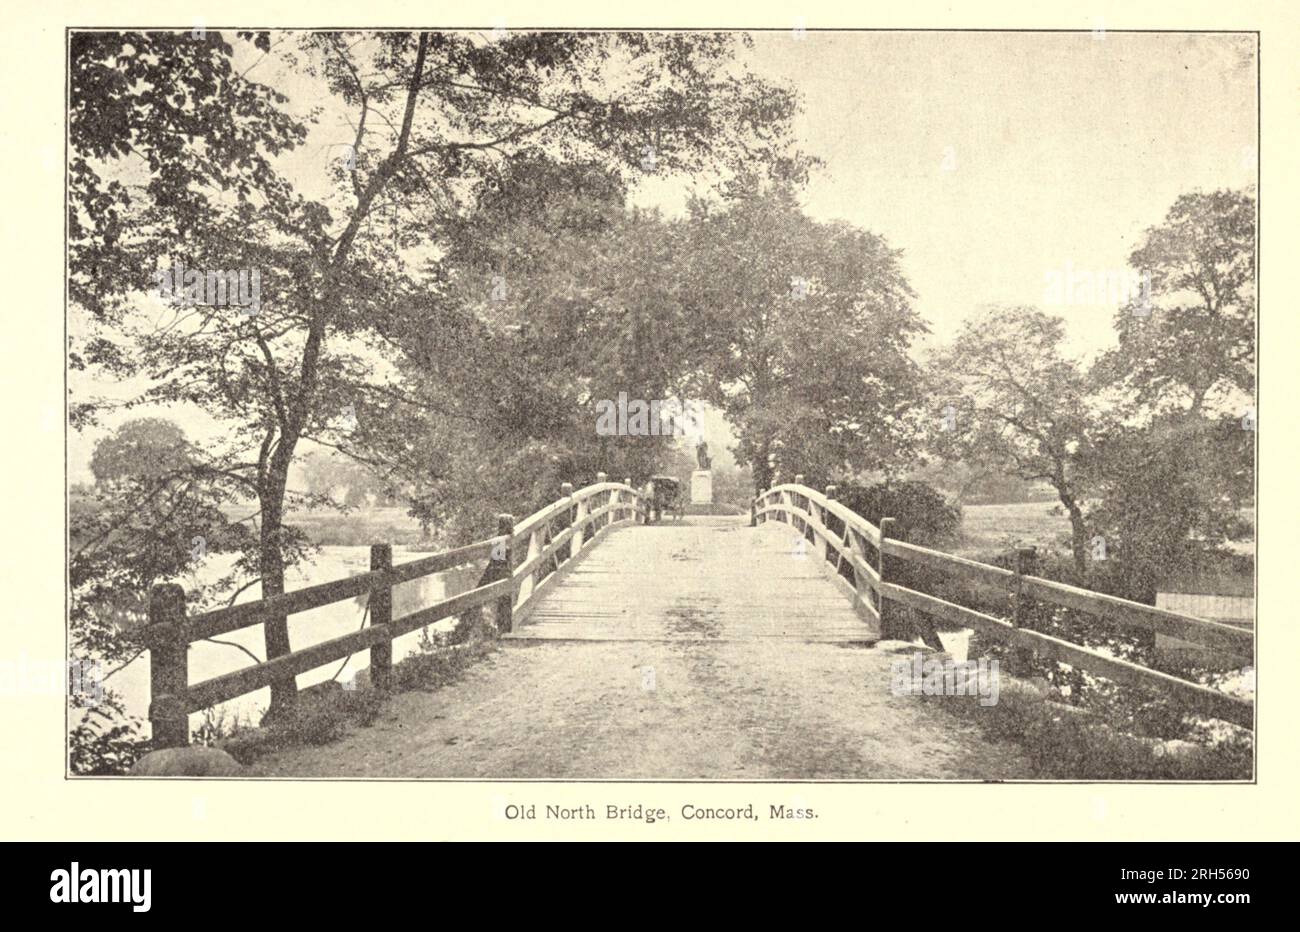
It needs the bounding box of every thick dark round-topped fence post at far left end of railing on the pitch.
[147,582,190,750]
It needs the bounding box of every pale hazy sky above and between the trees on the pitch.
[69,30,1257,482]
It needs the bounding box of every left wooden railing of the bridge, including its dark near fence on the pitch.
[144,473,645,747]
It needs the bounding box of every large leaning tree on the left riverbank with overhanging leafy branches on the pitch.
[69,32,802,707]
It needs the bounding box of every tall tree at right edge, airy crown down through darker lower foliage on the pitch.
[1088,191,1256,601]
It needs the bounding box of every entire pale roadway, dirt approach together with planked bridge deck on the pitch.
[250,519,1032,774]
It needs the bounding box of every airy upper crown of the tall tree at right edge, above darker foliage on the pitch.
[1102,191,1255,417]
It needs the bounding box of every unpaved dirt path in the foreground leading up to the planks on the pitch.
[252,641,1028,780]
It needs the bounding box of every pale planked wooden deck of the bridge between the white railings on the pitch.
[510,517,875,642]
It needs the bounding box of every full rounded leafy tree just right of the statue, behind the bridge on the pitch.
[683,187,926,490]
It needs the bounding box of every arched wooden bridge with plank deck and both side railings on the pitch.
[146,474,1255,776]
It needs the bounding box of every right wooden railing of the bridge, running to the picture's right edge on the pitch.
[750,476,1255,728]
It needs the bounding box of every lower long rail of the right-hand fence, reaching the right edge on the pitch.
[881,582,1255,728]
